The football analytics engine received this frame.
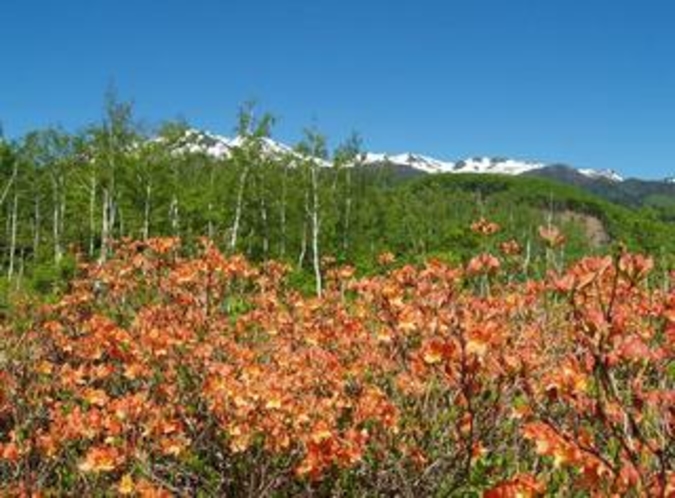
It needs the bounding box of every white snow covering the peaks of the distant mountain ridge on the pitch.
[165,129,628,182]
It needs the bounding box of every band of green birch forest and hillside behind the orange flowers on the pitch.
[0,96,675,306]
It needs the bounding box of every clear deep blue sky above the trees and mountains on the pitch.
[0,0,675,178]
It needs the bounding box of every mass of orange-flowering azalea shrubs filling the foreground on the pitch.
[0,235,675,497]
